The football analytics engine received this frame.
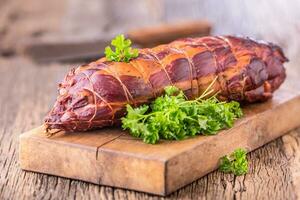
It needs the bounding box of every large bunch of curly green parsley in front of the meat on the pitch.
[122,79,242,144]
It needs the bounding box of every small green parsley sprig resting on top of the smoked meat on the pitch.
[104,35,138,62]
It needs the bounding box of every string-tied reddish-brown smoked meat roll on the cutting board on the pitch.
[45,36,287,131]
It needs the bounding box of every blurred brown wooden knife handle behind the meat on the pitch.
[127,20,211,47]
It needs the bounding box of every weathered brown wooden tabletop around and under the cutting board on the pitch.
[0,57,300,199]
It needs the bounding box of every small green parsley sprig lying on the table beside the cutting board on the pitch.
[219,149,248,176]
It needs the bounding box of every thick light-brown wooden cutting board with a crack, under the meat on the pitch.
[19,88,300,195]
